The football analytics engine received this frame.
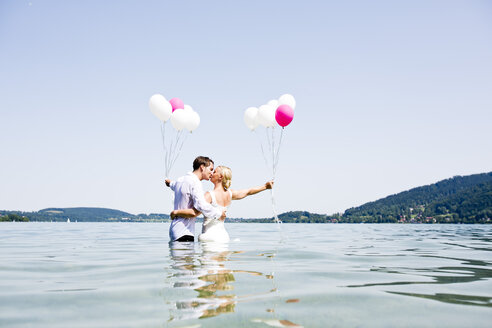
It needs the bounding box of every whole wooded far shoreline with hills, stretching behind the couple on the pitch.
[0,172,492,224]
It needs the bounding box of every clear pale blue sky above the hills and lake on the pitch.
[0,0,492,217]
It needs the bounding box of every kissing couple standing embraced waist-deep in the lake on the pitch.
[165,156,273,242]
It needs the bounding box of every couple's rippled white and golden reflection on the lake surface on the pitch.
[169,242,271,321]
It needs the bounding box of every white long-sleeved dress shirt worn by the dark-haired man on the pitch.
[169,172,222,241]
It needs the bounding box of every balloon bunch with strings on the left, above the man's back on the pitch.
[149,94,200,177]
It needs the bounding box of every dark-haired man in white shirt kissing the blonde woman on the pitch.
[166,156,226,241]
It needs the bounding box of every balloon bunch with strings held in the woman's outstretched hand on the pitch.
[244,94,296,222]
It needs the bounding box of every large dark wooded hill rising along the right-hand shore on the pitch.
[342,172,492,223]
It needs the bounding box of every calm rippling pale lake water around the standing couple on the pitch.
[0,223,492,327]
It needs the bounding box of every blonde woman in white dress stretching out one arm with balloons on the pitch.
[171,166,273,242]
